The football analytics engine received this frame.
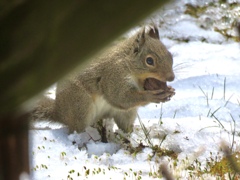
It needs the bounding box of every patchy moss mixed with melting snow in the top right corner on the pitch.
[184,0,240,42]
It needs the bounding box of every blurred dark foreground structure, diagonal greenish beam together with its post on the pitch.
[0,0,170,180]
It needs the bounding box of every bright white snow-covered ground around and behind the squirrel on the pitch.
[29,0,240,180]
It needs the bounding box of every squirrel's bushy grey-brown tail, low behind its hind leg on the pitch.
[32,97,55,121]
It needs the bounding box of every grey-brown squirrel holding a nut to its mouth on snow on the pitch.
[33,25,175,133]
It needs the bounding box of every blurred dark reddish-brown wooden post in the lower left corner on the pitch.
[0,114,29,180]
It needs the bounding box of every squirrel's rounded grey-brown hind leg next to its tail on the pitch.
[56,83,93,133]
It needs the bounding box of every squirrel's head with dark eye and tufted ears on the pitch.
[132,25,175,82]
